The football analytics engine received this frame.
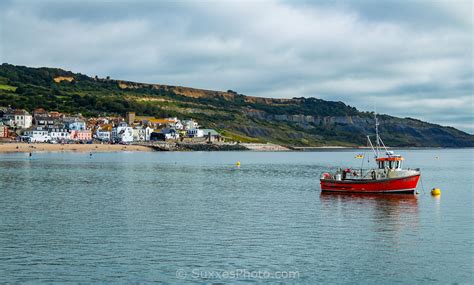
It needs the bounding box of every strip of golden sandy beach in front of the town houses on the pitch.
[0,143,153,153]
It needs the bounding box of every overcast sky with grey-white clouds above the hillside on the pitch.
[0,0,474,133]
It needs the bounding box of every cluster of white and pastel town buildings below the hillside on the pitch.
[0,107,223,144]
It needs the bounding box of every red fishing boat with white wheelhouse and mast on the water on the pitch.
[320,117,421,193]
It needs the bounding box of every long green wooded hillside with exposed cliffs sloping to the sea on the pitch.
[0,64,474,147]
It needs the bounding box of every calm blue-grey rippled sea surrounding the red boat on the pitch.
[0,149,474,284]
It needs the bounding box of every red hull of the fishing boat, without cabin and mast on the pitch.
[320,174,420,193]
